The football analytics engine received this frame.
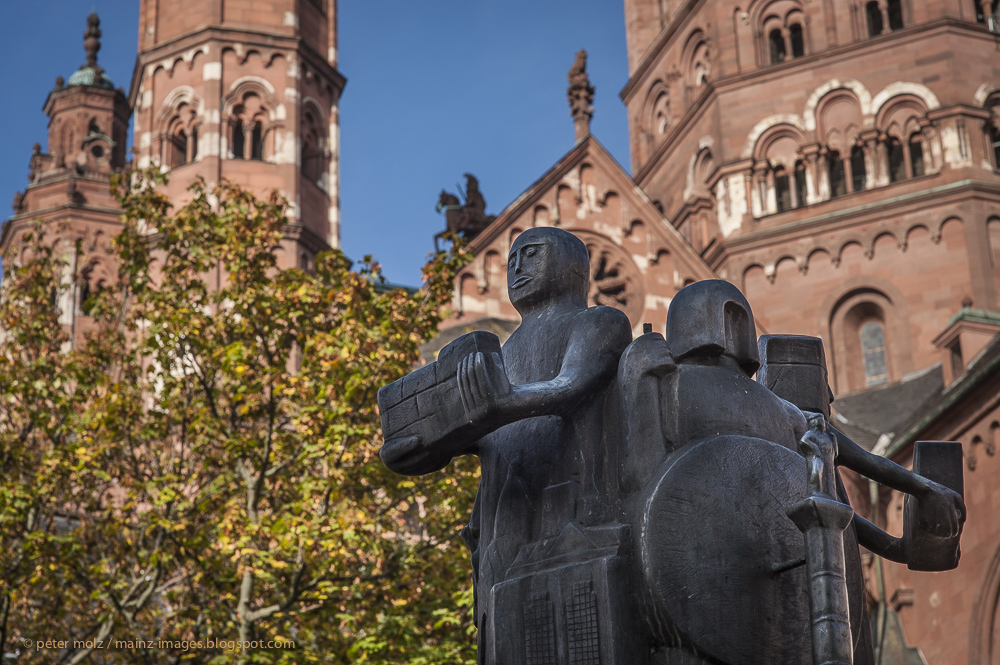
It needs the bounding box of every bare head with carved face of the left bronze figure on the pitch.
[507,226,590,314]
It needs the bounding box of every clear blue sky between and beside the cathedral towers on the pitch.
[0,0,629,284]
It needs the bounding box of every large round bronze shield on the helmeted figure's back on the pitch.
[639,436,864,665]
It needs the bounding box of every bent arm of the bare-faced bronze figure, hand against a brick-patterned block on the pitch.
[459,307,632,428]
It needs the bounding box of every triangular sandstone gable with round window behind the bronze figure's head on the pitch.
[452,136,716,328]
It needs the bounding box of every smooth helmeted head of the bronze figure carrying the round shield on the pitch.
[666,279,760,376]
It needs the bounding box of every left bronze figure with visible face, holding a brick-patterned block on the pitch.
[380,227,632,665]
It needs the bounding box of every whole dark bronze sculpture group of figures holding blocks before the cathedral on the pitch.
[379,245,965,665]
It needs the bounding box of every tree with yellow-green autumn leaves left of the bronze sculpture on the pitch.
[0,170,477,665]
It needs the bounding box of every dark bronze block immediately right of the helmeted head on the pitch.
[757,335,833,418]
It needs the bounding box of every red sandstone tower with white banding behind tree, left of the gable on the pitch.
[129,0,346,268]
